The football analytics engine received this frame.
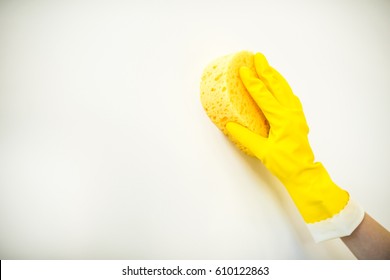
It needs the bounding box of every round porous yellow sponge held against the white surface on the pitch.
[200,51,269,156]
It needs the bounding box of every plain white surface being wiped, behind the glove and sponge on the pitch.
[0,0,390,259]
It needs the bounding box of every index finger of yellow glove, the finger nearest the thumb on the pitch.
[240,67,283,124]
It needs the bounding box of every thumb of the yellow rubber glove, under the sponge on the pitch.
[226,122,268,161]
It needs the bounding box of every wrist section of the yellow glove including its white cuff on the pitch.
[283,163,364,242]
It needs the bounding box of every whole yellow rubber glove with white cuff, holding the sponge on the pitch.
[226,53,364,241]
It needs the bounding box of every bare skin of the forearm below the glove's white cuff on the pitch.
[341,214,390,260]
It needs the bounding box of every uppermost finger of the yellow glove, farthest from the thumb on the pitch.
[254,53,296,108]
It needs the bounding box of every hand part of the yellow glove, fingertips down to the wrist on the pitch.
[226,53,314,185]
